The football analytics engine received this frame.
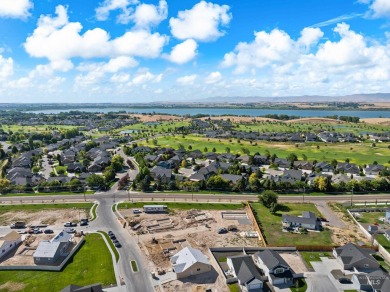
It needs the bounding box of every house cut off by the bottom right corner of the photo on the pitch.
[352,270,390,292]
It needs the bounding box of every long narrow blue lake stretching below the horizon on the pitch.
[29,107,390,119]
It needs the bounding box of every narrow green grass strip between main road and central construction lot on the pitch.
[118,202,244,210]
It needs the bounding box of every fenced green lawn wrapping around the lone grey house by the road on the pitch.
[252,203,333,246]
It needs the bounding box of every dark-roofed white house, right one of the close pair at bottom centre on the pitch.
[253,249,294,287]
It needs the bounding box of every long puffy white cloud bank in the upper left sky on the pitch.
[24,5,168,65]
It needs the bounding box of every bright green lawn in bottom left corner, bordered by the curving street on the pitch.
[0,234,116,292]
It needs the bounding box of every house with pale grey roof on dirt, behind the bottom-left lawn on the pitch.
[33,231,73,265]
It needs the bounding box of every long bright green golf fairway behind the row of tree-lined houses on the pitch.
[139,135,390,165]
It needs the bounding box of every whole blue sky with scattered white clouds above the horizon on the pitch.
[0,0,390,103]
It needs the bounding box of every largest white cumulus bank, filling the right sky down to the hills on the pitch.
[221,23,390,95]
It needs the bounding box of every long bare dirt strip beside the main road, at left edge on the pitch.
[0,209,88,226]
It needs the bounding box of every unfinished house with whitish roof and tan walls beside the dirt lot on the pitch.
[170,247,211,279]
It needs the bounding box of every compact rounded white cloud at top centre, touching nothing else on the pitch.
[169,1,232,41]
